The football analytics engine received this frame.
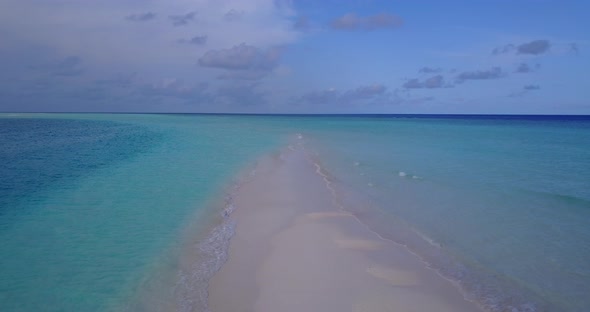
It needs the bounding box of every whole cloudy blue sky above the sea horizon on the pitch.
[0,0,590,114]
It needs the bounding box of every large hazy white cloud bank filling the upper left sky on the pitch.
[0,0,298,78]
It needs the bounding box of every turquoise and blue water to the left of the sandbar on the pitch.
[0,115,280,311]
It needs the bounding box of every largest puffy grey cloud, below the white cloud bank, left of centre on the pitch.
[199,43,282,71]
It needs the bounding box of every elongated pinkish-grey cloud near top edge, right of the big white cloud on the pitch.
[330,13,403,31]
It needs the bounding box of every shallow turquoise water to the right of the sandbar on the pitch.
[300,118,590,311]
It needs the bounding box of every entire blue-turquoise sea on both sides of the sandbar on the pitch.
[0,114,590,312]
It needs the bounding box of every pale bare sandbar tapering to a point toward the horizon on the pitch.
[209,146,481,312]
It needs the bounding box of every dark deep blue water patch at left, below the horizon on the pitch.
[0,118,163,216]
